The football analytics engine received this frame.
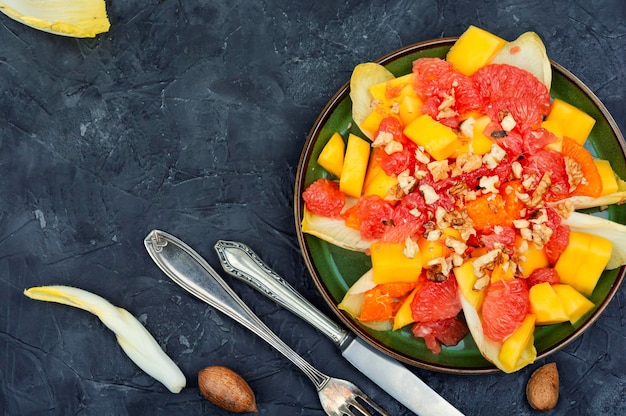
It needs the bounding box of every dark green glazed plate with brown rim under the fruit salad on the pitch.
[294,38,626,374]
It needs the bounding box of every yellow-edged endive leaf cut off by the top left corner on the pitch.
[0,0,111,38]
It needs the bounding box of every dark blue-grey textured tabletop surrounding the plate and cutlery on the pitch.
[0,0,626,415]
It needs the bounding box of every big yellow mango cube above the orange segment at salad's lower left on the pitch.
[370,241,422,284]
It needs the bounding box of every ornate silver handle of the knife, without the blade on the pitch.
[215,240,349,347]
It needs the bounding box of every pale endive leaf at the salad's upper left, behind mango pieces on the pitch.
[350,62,395,140]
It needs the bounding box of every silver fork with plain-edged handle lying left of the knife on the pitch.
[144,230,390,416]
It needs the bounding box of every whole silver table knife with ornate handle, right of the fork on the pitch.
[215,240,463,416]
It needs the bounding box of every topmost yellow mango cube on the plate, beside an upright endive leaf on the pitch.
[446,26,506,75]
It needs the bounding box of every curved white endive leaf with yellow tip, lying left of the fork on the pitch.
[24,286,186,393]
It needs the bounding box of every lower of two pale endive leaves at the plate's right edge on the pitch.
[563,212,626,270]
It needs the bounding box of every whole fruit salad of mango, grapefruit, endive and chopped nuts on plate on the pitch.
[302,26,626,372]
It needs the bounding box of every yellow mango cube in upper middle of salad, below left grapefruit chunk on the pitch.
[404,114,459,160]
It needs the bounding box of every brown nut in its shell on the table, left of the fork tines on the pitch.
[198,366,258,413]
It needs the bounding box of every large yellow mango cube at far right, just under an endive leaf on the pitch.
[554,231,612,296]
